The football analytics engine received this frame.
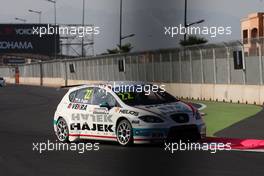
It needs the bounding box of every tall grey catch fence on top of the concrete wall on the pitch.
[0,39,264,85]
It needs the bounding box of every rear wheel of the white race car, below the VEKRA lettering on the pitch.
[56,118,69,142]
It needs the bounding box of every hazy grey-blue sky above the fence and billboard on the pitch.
[0,0,264,54]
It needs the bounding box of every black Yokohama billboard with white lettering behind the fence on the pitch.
[0,24,60,55]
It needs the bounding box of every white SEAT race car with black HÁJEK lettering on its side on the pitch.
[54,82,206,146]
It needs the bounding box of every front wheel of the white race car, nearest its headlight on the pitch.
[116,120,133,146]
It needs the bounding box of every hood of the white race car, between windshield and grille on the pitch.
[135,101,193,116]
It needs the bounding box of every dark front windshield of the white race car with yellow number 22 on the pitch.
[115,85,179,106]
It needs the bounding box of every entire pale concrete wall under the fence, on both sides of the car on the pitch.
[5,77,264,105]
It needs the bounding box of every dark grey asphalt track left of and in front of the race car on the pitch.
[0,85,264,176]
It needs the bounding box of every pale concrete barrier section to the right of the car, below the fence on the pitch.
[164,83,264,105]
